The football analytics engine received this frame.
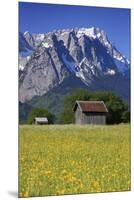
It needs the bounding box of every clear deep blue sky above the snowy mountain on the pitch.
[19,2,130,59]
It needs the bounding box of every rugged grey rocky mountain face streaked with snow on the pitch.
[19,27,130,102]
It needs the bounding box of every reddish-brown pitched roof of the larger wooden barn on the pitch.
[73,101,108,113]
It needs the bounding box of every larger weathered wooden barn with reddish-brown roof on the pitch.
[73,101,108,124]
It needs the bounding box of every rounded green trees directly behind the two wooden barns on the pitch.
[28,89,130,124]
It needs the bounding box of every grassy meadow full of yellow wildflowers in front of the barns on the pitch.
[19,124,130,197]
